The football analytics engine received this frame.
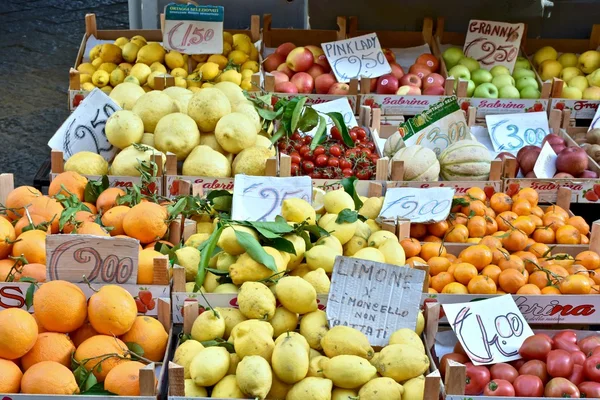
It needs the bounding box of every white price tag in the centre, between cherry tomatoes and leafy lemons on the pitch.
[231,175,312,221]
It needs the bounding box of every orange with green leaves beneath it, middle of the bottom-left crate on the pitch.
[74,335,129,382]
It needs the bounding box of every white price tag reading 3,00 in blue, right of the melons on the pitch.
[485,111,550,155]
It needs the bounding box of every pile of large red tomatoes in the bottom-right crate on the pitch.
[440,330,600,398]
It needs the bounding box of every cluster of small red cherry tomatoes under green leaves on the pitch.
[278,126,379,180]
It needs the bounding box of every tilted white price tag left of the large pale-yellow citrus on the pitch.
[48,88,121,161]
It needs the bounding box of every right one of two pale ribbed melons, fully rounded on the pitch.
[439,140,492,181]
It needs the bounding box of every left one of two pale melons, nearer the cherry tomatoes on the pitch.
[390,145,440,181]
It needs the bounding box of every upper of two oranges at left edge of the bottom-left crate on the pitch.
[0,308,38,360]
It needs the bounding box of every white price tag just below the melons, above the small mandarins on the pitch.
[379,187,454,223]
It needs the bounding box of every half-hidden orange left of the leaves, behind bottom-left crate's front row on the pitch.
[21,332,75,371]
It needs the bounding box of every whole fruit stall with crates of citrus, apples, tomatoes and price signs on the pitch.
[0,3,600,400]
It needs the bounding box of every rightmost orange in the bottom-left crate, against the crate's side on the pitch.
[121,316,169,361]
